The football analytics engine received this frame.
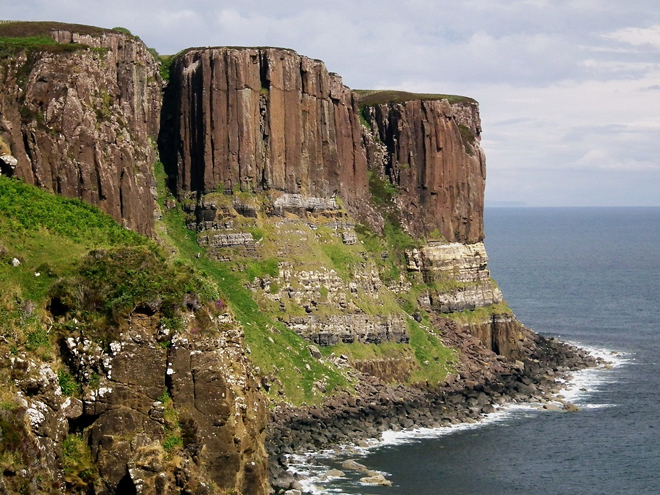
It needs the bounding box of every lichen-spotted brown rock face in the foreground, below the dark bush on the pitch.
[12,314,268,494]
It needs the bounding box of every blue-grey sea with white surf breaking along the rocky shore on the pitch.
[292,207,660,495]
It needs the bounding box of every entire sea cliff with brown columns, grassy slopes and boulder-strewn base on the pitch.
[0,22,589,494]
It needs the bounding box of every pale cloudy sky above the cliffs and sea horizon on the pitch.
[0,0,660,206]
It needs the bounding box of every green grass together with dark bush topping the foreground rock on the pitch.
[0,177,219,360]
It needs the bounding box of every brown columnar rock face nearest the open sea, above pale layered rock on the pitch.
[364,99,486,243]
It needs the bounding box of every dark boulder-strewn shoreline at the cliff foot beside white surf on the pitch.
[267,328,604,494]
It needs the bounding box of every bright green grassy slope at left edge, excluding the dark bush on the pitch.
[0,177,150,359]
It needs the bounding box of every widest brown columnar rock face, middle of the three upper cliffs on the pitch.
[161,48,367,202]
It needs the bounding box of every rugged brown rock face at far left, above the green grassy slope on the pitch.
[0,23,161,234]
